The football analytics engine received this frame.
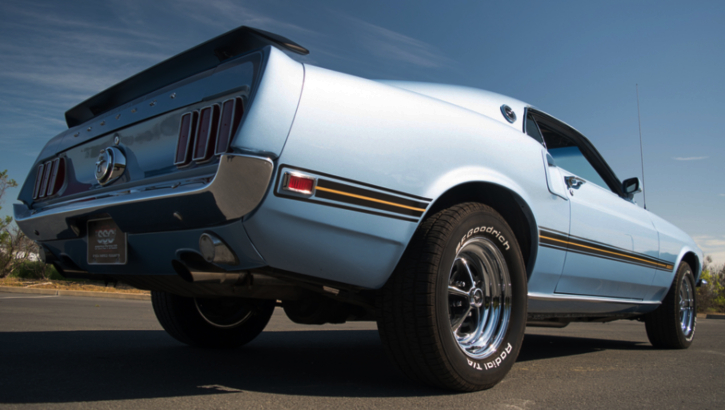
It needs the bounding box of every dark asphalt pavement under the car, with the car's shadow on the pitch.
[0,293,725,410]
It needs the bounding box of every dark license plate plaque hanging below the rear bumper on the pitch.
[87,218,128,265]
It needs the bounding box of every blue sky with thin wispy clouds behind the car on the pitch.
[0,0,725,263]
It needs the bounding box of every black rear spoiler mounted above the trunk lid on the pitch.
[65,26,310,128]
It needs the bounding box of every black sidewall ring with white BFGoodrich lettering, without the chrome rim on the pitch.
[435,210,527,386]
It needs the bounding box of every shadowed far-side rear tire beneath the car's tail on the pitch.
[151,291,275,348]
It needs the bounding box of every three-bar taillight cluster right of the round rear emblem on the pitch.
[174,97,244,167]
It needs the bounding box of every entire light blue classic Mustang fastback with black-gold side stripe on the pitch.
[14,27,702,391]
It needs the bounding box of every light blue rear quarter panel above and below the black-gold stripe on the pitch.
[245,65,568,288]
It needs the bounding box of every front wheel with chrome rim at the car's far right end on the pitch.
[644,262,697,349]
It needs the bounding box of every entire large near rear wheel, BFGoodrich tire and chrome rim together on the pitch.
[378,203,527,391]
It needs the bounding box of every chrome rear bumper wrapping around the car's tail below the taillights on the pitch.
[14,154,274,241]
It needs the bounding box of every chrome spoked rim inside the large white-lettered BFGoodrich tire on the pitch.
[448,237,512,359]
